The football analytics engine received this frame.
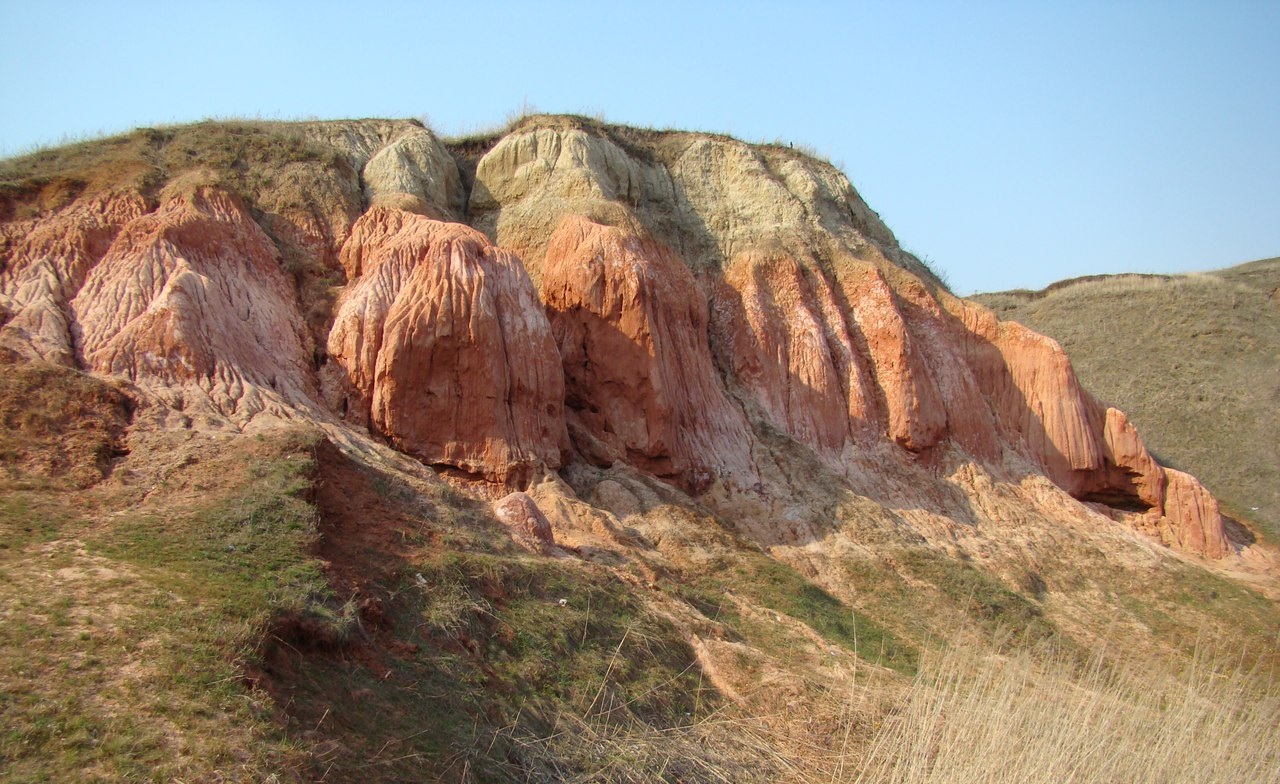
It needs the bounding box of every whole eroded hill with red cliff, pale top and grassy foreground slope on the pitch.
[0,117,1280,781]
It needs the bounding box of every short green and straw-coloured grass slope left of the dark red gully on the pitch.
[0,433,330,781]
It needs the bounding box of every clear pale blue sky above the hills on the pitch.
[0,0,1280,293]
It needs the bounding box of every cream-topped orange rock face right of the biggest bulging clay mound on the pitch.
[471,116,1225,556]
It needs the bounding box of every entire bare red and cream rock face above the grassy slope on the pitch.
[0,118,1233,557]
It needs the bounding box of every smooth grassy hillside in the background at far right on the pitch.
[974,259,1280,537]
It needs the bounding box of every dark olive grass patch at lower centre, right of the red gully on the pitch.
[408,552,696,724]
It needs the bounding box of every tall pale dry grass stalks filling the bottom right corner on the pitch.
[856,637,1280,784]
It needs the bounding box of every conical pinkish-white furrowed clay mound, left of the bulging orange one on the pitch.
[70,187,315,420]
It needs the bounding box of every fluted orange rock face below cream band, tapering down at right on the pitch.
[714,242,1229,557]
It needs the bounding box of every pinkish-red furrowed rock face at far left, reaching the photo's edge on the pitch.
[3,186,314,419]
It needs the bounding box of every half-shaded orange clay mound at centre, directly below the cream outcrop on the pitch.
[543,216,756,492]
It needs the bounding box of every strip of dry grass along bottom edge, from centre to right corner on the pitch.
[481,630,1280,784]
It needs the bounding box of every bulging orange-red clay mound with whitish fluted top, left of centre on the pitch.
[329,208,567,484]
